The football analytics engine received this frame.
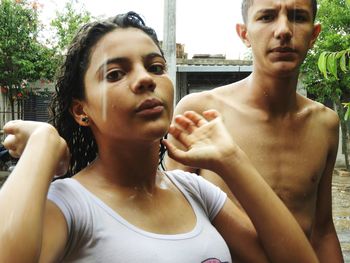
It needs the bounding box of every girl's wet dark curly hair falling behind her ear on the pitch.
[50,12,165,177]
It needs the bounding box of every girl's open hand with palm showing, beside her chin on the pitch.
[164,110,239,171]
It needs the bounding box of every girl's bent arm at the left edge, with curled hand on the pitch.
[0,121,68,262]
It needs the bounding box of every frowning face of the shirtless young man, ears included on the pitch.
[237,0,320,76]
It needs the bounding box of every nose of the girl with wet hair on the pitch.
[131,67,156,93]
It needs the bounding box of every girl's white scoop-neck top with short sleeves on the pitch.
[48,170,231,263]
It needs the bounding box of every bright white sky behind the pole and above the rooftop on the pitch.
[39,0,247,59]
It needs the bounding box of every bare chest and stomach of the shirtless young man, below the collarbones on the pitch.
[216,105,329,232]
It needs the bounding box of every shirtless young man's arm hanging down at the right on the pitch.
[311,112,344,263]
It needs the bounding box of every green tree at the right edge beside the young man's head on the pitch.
[301,0,350,169]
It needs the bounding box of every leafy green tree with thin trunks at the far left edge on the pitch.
[0,0,52,119]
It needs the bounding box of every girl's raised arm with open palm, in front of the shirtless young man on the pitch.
[165,110,318,263]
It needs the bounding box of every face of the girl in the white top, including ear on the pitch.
[78,28,174,142]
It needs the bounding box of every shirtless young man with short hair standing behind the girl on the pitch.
[166,0,343,262]
